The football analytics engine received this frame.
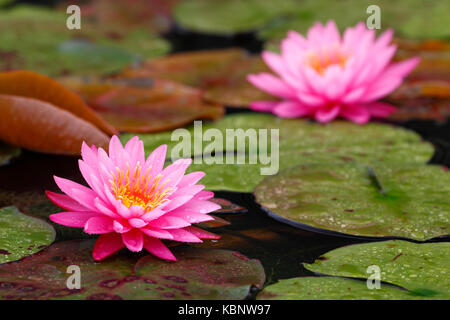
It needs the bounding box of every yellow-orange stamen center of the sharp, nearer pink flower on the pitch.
[110,162,173,212]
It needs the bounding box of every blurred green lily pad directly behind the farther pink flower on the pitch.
[259,0,450,44]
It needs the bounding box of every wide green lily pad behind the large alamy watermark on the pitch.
[121,113,434,192]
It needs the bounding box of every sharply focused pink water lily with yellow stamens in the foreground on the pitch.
[47,136,220,261]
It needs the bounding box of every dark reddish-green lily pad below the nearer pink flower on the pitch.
[0,240,265,300]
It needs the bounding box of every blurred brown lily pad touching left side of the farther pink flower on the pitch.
[122,49,273,107]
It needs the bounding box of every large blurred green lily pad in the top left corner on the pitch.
[0,6,169,76]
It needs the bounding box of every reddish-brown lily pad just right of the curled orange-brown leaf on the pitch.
[62,78,224,132]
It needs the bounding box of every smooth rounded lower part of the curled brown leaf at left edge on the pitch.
[0,95,109,155]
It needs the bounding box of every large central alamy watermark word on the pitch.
[170,121,280,175]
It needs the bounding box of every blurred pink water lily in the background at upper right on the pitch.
[248,21,419,123]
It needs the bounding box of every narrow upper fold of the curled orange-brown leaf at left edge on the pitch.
[0,71,116,135]
